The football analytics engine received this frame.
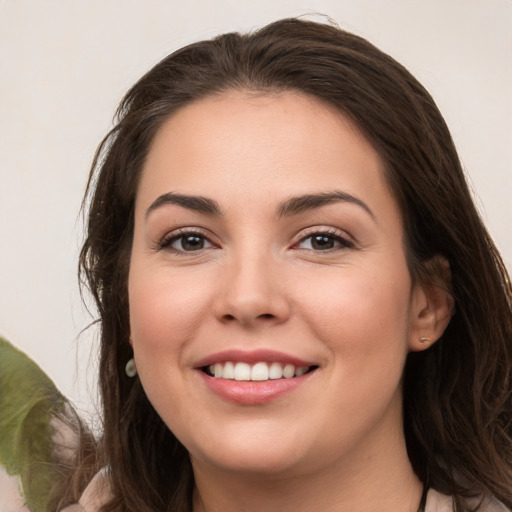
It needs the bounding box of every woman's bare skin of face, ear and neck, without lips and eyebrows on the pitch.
[129,91,451,512]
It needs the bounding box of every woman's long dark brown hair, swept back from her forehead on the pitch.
[80,19,512,512]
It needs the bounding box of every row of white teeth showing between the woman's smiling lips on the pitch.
[201,361,318,382]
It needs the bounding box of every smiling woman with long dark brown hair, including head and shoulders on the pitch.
[2,20,512,512]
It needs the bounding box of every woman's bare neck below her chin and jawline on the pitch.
[193,432,423,512]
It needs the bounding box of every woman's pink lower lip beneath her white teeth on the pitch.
[198,370,315,405]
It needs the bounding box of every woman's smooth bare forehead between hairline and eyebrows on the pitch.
[137,91,396,218]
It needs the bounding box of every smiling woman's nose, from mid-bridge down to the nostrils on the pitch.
[214,256,290,327]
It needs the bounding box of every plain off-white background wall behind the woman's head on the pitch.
[0,0,512,416]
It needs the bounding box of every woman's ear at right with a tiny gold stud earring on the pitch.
[408,256,455,352]
